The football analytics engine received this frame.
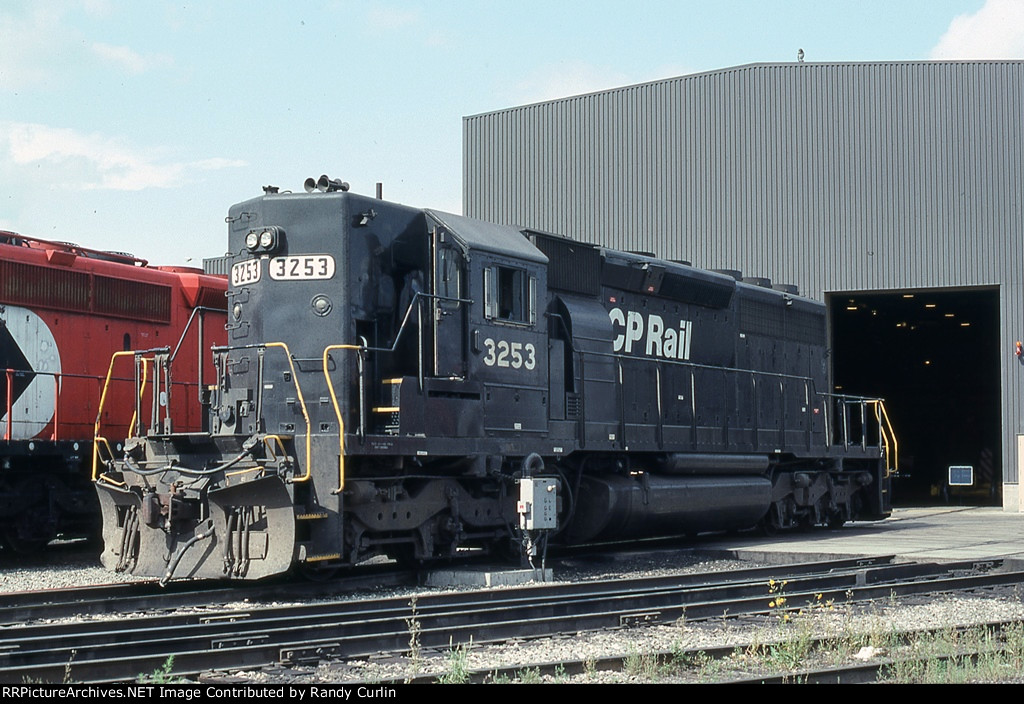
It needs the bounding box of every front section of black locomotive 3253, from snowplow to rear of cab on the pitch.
[92,187,561,578]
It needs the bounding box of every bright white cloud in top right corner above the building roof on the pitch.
[931,0,1024,59]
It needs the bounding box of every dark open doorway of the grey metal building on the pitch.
[826,288,1002,505]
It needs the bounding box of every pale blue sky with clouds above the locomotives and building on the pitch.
[0,0,1024,266]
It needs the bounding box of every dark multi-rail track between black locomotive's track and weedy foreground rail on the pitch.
[0,557,1024,683]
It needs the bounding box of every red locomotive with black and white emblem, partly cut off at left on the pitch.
[0,231,227,553]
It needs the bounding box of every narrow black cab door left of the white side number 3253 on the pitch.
[430,227,467,379]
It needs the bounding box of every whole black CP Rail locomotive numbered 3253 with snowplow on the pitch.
[97,177,895,580]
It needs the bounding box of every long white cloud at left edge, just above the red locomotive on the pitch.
[0,123,245,190]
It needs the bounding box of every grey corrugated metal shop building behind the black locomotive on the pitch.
[463,61,1024,510]
